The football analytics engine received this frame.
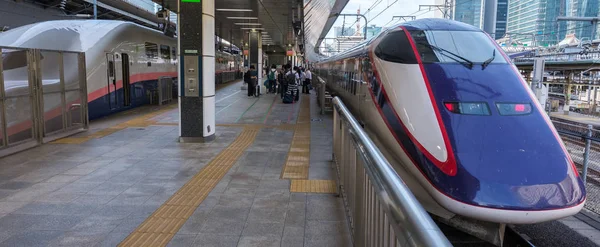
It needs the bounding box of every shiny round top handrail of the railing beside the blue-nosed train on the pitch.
[333,97,452,247]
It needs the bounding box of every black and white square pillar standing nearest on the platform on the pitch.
[177,0,215,142]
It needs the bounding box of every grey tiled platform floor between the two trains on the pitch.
[0,80,351,246]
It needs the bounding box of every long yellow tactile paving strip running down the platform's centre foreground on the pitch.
[118,128,259,247]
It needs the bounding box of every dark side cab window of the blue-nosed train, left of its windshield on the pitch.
[375,30,417,64]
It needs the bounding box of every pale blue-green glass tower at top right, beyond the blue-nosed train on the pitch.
[506,0,567,46]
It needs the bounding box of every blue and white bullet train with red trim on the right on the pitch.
[315,19,586,241]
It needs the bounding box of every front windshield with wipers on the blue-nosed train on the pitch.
[410,30,507,65]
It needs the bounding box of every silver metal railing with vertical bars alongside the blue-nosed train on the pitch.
[332,97,452,247]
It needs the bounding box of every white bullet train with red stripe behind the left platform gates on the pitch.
[0,20,239,119]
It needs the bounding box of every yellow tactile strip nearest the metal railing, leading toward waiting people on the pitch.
[281,95,310,179]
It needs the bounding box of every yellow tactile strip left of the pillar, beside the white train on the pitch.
[52,104,177,144]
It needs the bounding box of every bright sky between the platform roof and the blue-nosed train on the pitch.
[327,0,443,37]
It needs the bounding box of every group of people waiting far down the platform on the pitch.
[244,64,312,103]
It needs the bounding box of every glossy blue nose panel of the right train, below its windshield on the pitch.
[425,64,585,210]
